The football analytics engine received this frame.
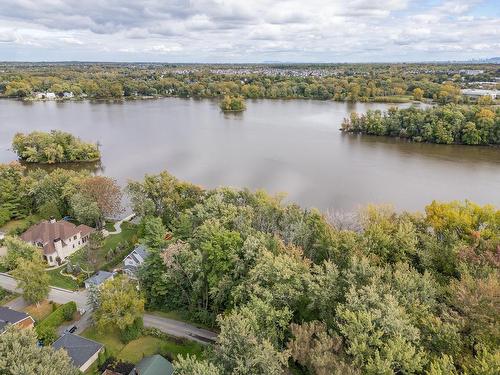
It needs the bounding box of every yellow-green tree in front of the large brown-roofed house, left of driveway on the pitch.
[12,259,50,304]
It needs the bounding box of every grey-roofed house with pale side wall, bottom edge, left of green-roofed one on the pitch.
[52,333,104,372]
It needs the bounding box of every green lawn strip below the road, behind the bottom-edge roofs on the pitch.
[82,327,203,363]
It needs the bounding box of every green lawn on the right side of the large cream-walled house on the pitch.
[70,222,138,271]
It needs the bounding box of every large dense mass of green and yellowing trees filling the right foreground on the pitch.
[123,172,500,375]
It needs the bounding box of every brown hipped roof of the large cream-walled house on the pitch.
[21,220,95,255]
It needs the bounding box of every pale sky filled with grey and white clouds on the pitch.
[0,0,500,63]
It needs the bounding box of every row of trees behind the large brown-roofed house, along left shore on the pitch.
[0,162,121,234]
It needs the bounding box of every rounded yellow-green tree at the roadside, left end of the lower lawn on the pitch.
[94,276,144,331]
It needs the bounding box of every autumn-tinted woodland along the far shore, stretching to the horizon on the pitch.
[0,63,500,103]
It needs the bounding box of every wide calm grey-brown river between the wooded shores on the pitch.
[0,98,500,210]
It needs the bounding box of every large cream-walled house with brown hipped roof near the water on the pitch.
[21,219,95,266]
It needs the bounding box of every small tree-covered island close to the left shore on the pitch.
[12,130,101,164]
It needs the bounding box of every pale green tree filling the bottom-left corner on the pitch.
[0,326,80,375]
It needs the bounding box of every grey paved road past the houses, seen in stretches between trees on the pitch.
[0,274,217,344]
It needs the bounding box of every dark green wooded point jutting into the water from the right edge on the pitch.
[341,104,500,145]
